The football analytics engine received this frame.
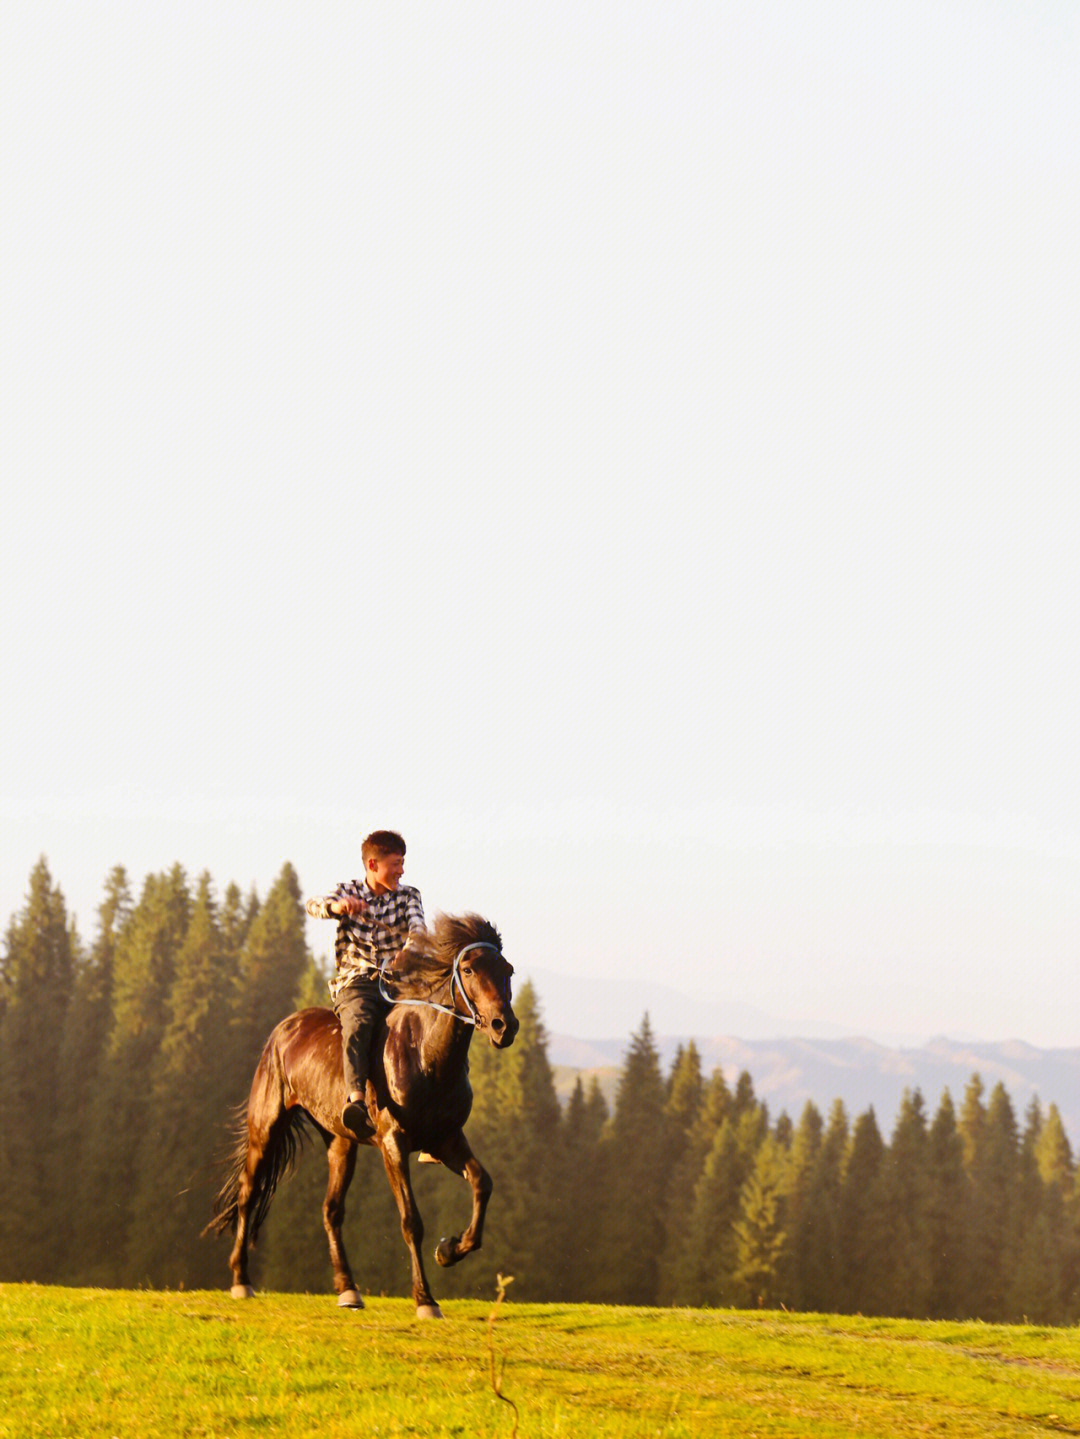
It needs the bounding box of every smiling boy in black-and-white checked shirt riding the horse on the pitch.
[305,829,424,1134]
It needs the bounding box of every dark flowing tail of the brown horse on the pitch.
[203,1035,308,1243]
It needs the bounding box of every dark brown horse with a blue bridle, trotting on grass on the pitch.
[203,914,518,1318]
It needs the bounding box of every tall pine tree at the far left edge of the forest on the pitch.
[0,856,82,1282]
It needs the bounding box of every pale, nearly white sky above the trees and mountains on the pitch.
[0,0,1080,1046]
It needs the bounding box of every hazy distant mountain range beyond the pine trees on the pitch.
[548,1033,1080,1145]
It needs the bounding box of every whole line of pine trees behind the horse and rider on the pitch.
[0,859,1080,1324]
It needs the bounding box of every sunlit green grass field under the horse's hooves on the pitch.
[0,1285,1080,1439]
